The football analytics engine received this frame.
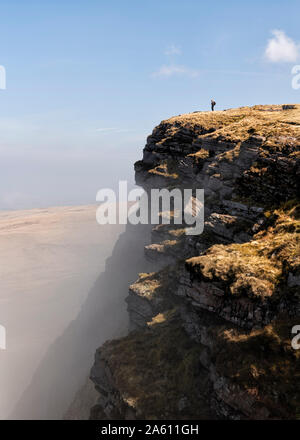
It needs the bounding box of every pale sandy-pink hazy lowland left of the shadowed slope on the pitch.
[0,206,125,419]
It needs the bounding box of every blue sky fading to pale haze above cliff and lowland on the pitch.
[0,0,300,208]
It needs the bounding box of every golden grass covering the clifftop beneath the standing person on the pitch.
[161,105,300,151]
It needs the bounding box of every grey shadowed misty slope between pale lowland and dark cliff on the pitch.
[5,220,155,419]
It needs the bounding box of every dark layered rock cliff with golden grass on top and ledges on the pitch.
[91,105,300,419]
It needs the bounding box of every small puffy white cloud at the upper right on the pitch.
[265,29,300,63]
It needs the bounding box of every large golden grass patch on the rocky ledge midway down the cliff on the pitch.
[187,204,300,299]
